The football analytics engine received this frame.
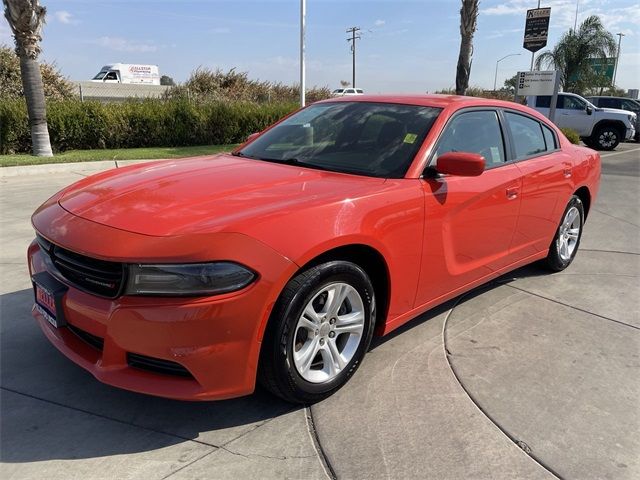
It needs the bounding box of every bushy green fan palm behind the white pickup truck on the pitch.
[536,15,616,93]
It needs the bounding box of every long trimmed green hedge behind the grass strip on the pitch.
[0,99,296,154]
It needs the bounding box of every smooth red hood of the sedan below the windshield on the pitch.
[59,155,384,236]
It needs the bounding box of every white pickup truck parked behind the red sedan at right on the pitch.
[527,92,637,150]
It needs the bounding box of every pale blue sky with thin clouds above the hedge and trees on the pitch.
[0,0,640,93]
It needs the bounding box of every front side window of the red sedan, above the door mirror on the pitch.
[432,111,505,168]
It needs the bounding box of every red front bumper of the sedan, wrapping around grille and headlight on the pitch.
[28,200,297,400]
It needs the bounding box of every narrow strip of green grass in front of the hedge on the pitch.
[0,145,236,167]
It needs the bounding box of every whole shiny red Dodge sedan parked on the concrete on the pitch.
[28,95,600,402]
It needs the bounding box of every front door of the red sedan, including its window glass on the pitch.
[416,109,521,306]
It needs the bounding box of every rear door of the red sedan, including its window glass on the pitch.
[504,111,573,260]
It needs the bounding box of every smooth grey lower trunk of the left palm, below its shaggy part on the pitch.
[20,55,53,157]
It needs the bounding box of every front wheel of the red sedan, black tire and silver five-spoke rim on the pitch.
[258,261,375,404]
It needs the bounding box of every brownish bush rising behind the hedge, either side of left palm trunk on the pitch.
[0,45,75,100]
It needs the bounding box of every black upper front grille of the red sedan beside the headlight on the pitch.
[37,235,125,298]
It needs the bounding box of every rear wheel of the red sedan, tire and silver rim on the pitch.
[544,195,584,272]
